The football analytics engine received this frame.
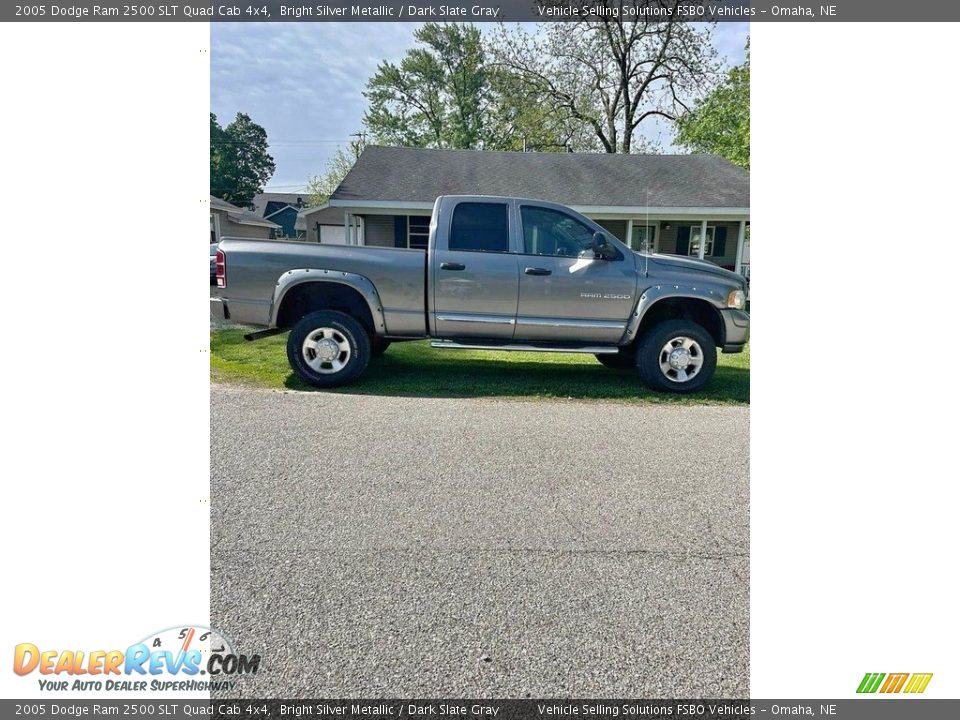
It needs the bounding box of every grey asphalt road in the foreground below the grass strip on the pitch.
[210,385,750,698]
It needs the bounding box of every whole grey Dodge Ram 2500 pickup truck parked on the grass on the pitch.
[210,195,750,393]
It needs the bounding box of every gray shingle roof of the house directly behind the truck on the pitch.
[331,145,750,208]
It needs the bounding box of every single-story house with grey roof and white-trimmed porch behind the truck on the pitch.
[300,146,750,272]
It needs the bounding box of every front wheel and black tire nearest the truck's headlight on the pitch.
[637,320,717,393]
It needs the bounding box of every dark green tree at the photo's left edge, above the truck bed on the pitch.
[210,113,276,207]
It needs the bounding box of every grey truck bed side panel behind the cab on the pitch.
[220,238,427,337]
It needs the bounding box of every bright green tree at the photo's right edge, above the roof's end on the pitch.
[676,42,750,170]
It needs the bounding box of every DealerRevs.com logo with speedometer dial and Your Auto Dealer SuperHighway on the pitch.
[13,625,260,692]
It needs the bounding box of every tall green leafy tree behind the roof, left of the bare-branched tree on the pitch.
[363,23,486,148]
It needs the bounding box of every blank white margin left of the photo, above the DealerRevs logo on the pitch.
[0,23,210,697]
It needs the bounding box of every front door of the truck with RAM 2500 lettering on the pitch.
[514,205,637,344]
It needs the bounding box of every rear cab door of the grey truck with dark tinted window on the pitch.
[431,201,517,340]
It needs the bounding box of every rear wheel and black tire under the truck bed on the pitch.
[287,310,370,388]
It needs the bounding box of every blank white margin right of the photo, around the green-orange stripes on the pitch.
[750,23,960,698]
